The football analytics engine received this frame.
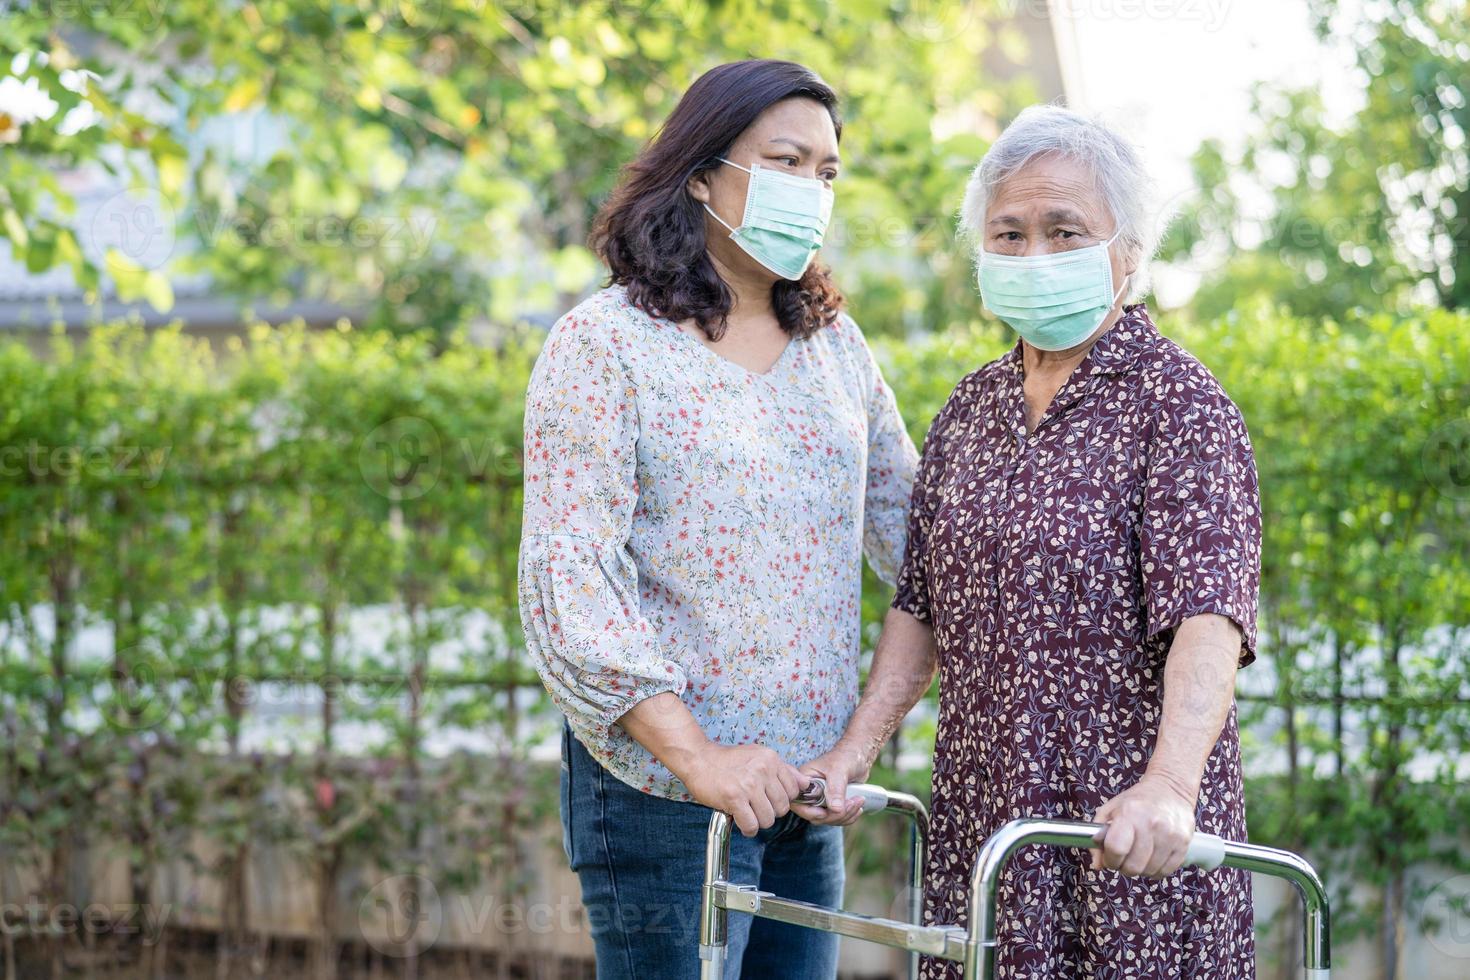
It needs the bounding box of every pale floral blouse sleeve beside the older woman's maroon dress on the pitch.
[844,316,919,585]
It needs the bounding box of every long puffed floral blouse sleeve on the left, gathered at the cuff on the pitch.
[519,314,686,754]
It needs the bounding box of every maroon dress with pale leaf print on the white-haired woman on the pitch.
[894,304,1261,980]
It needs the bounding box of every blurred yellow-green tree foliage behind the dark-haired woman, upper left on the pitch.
[0,0,1039,334]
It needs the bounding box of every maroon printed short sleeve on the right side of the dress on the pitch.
[1139,369,1261,667]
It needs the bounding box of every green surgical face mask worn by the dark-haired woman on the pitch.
[704,157,832,279]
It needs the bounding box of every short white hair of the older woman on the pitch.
[960,106,1163,303]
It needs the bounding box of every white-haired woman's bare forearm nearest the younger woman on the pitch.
[839,610,935,768]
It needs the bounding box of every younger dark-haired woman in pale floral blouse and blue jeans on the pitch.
[520,60,917,980]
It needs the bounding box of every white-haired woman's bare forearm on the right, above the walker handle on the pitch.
[1145,613,1241,805]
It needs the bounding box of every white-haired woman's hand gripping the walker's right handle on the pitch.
[1089,773,1195,879]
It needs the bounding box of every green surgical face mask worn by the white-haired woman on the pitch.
[979,232,1127,351]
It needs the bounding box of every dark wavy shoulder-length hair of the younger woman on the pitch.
[589,59,844,341]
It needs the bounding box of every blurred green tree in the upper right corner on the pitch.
[1163,0,1470,322]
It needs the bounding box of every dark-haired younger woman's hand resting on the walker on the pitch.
[675,742,810,837]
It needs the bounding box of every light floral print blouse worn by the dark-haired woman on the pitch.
[519,285,917,799]
